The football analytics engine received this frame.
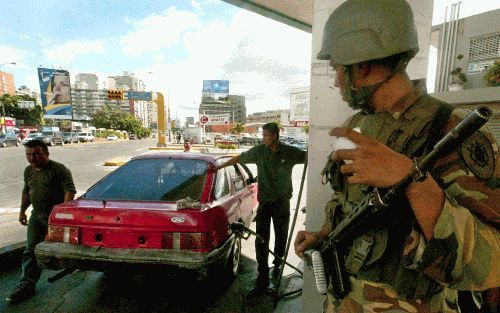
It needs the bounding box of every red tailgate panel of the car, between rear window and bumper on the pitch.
[46,199,228,252]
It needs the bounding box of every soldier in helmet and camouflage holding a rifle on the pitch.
[295,0,500,313]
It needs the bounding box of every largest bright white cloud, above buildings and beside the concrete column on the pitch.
[130,10,311,118]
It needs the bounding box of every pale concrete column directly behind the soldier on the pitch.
[303,0,433,312]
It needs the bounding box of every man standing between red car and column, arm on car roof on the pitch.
[216,123,306,291]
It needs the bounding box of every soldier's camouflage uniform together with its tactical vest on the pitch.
[325,89,500,313]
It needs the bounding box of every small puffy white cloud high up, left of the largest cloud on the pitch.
[120,7,198,56]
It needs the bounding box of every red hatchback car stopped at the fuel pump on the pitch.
[35,153,258,278]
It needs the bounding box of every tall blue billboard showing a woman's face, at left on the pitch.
[38,67,72,119]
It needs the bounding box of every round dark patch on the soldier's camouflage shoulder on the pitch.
[459,131,495,180]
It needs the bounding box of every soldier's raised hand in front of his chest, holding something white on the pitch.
[330,128,413,188]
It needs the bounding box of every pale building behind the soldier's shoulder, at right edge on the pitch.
[431,6,500,142]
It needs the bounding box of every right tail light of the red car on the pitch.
[162,233,215,252]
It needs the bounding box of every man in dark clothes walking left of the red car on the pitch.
[7,140,76,303]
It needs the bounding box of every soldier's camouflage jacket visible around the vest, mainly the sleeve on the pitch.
[325,95,500,313]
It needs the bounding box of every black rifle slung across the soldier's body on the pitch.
[312,107,492,299]
